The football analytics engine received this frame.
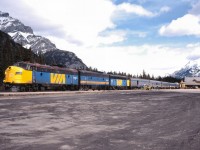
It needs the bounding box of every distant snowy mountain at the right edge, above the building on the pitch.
[172,59,200,78]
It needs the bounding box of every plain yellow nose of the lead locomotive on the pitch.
[3,66,32,84]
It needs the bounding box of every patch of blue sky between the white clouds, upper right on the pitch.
[109,0,195,45]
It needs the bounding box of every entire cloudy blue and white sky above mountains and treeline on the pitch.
[0,0,200,76]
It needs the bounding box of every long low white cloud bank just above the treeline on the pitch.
[48,36,189,76]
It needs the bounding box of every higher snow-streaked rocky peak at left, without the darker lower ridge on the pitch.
[0,11,57,53]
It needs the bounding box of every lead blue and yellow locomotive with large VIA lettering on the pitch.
[3,62,78,91]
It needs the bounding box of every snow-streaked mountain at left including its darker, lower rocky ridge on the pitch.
[0,11,87,68]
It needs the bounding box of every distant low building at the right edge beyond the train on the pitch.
[184,77,200,88]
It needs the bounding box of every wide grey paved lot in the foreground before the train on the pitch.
[0,90,200,150]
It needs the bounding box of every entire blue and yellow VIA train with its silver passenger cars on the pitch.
[3,62,179,91]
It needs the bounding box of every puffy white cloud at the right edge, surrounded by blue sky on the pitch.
[159,14,200,36]
